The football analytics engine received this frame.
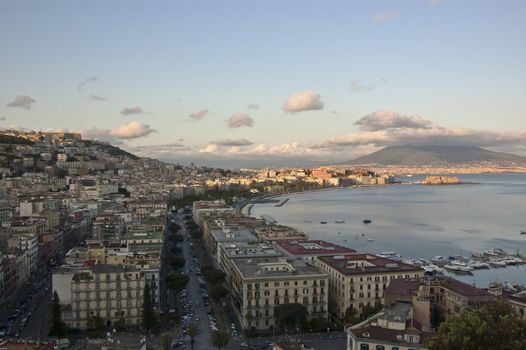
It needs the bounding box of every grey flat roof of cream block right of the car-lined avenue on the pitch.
[232,257,327,279]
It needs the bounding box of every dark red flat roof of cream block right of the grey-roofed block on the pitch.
[318,253,423,275]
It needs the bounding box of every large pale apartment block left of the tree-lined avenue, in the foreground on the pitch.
[53,265,159,329]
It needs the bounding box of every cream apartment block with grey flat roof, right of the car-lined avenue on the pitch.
[231,257,328,330]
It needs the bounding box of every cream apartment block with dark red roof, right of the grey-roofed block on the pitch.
[315,254,424,318]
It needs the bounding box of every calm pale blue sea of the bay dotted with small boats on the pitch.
[251,173,526,288]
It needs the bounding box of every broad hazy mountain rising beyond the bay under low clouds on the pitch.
[351,145,526,166]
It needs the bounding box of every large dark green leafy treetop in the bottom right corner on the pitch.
[426,300,526,350]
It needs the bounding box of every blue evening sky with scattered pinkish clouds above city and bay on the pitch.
[0,0,526,167]
